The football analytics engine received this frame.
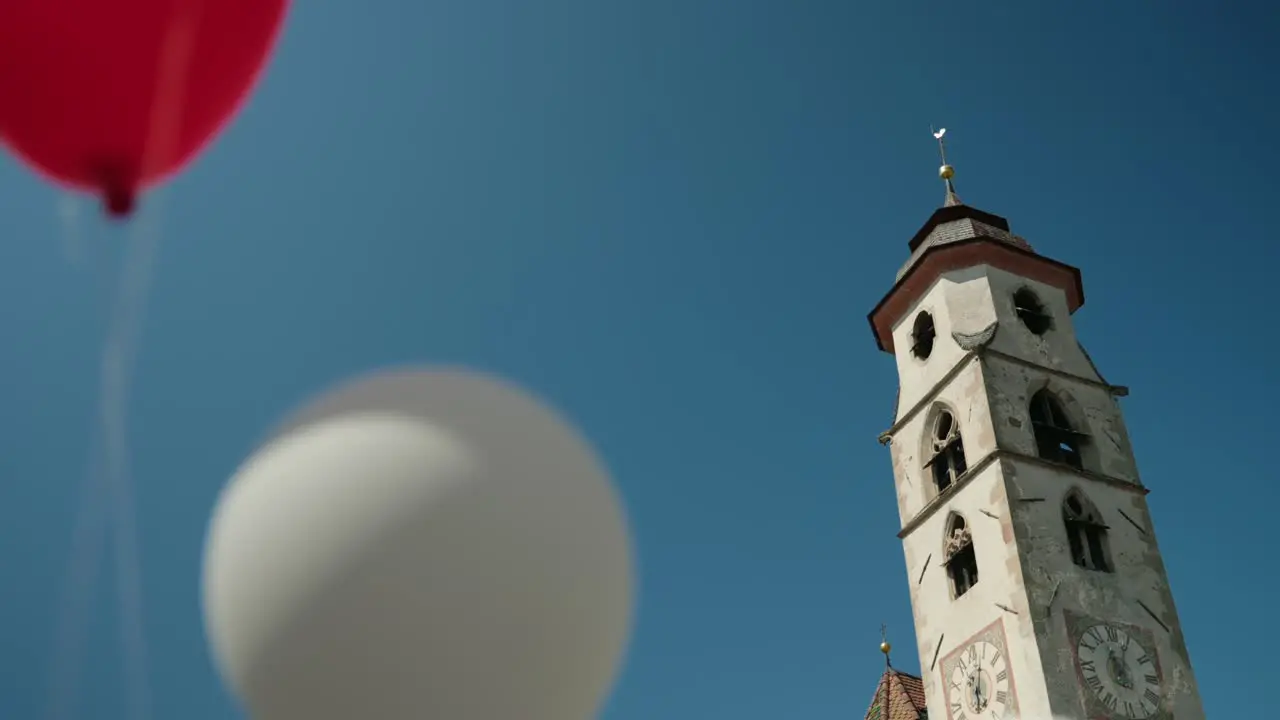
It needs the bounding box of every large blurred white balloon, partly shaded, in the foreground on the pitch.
[204,372,632,720]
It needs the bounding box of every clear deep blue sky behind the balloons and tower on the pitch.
[0,0,1280,720]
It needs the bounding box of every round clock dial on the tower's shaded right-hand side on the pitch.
[1075,623,1161,720]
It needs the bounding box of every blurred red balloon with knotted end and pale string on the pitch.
[0,0,288,215]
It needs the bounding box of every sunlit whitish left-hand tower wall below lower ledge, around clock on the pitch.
[902,462,1048,717]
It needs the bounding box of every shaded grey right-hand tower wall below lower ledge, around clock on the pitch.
[1005,462,1204,720]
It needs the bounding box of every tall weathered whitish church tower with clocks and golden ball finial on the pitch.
[868,129,1204,720]
